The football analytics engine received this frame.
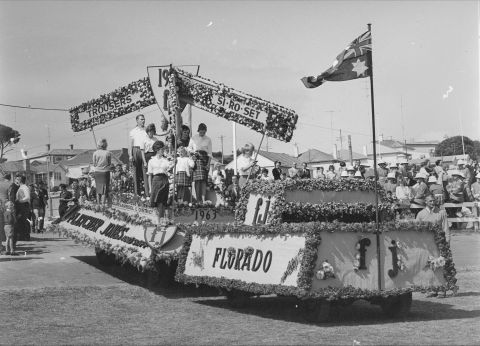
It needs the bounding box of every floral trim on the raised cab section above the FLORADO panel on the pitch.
[235,179,394,224]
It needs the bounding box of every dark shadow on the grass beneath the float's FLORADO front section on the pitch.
[196,297,480,327]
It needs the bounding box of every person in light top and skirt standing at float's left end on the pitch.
[93,138,111,204]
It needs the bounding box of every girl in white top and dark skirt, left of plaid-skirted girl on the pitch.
[147,141,172,224]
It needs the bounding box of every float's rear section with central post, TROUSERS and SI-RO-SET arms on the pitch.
[48,65,298,283]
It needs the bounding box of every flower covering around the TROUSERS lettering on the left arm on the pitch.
[70,78,155,132]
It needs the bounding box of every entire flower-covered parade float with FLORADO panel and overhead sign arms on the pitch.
[48,59,456,321]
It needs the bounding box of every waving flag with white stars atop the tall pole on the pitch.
[301,31,372,88]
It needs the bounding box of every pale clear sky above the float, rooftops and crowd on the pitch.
[0,1,480,160]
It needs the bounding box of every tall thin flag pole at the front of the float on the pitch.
[367,24,383,290]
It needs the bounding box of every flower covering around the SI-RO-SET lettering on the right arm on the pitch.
[175,68,298,142]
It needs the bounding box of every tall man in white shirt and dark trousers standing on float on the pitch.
[129,114,148,195]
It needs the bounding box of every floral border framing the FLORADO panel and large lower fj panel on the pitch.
[176,221,458,300]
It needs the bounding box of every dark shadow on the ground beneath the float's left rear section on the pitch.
[72,256,220,299]
